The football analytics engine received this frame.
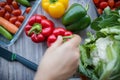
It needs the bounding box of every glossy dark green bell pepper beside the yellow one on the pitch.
[62,3,91,32]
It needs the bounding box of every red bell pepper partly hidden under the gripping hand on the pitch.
[47,27,72,47]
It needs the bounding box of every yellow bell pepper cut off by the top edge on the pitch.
[42,0,69,18]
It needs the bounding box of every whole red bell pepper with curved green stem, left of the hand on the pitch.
[25,14,54,43]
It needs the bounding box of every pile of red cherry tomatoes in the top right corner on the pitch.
[93,0,120,14]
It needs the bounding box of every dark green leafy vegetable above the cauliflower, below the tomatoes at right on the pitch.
[91,7,120,31]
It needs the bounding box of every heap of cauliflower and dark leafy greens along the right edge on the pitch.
[79,8,120,80]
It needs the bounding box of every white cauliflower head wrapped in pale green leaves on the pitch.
[79,36,120,80]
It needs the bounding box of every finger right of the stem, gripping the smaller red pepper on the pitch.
[65,35,81,47]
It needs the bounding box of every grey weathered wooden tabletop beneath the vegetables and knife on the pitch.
[0,0,97,80]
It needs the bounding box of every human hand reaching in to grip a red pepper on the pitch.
[35,35,81,80]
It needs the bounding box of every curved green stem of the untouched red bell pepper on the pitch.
[28,23,42,35]
